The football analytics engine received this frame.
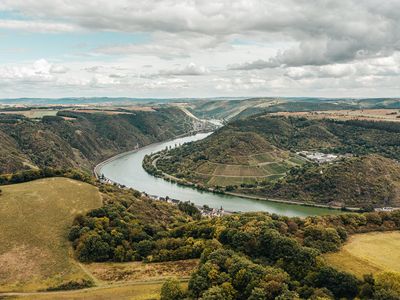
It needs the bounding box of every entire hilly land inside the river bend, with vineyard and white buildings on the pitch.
[150,115,400,207]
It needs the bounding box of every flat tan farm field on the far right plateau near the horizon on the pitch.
[271,109,400,122]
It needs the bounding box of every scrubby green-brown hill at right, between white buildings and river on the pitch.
[244,155,400,208]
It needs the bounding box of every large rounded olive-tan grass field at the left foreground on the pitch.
[0,178,102,292]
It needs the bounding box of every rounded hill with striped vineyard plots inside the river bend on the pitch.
[155,130,305,186]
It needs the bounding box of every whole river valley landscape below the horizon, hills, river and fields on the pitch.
[0,100,400,299]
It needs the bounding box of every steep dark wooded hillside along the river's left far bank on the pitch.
[0,108,192,173]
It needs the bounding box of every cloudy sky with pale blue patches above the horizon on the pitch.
[0,0,400,98]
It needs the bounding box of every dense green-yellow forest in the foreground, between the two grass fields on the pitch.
[69,186,400,299]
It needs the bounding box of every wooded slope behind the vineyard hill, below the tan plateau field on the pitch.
[222,115,400,160]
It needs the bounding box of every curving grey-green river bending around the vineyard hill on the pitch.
[98,133,340,217]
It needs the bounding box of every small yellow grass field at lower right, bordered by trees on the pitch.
[323,231,400,277]
